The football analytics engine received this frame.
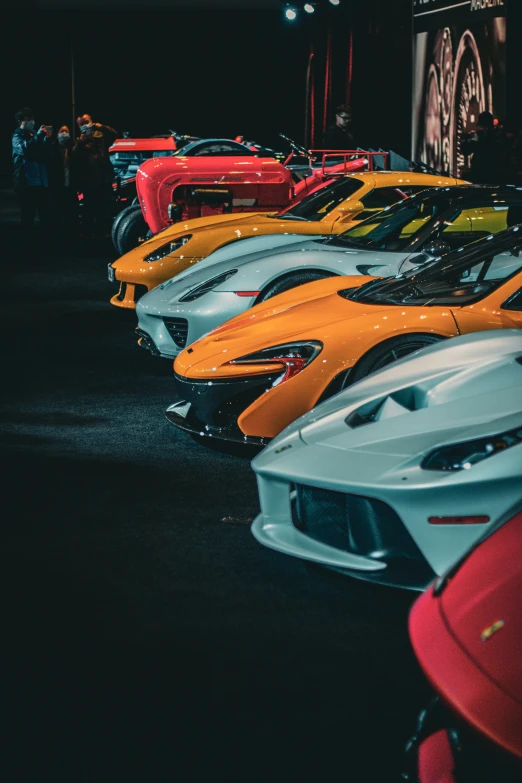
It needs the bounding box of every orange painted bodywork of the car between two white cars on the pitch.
[174,227,522,438]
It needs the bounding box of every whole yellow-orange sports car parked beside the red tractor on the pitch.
[109,171,465,308]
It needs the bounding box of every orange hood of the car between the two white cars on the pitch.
[174,275,390,376]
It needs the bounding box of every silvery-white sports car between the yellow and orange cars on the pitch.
[136,185,522,358]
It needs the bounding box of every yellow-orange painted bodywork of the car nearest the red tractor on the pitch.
[111,172,464,308]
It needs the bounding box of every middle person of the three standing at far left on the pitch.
[49,125,78,239]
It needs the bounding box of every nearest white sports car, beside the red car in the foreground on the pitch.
[252,329,522,589]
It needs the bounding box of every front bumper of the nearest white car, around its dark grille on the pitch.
[252,431,520,590]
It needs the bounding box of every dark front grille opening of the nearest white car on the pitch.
[292,484,423,560]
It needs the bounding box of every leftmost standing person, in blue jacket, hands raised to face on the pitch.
[12,108,54,240]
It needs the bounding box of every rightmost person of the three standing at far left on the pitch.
[72,114,118,236]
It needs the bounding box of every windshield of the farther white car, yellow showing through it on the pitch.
[328,192,450,252]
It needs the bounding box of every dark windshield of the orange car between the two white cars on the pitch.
[339,226,522,307]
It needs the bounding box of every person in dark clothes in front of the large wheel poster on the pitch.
[462,111,514,185]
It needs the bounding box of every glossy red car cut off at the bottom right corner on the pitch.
[404,509,522,783]
